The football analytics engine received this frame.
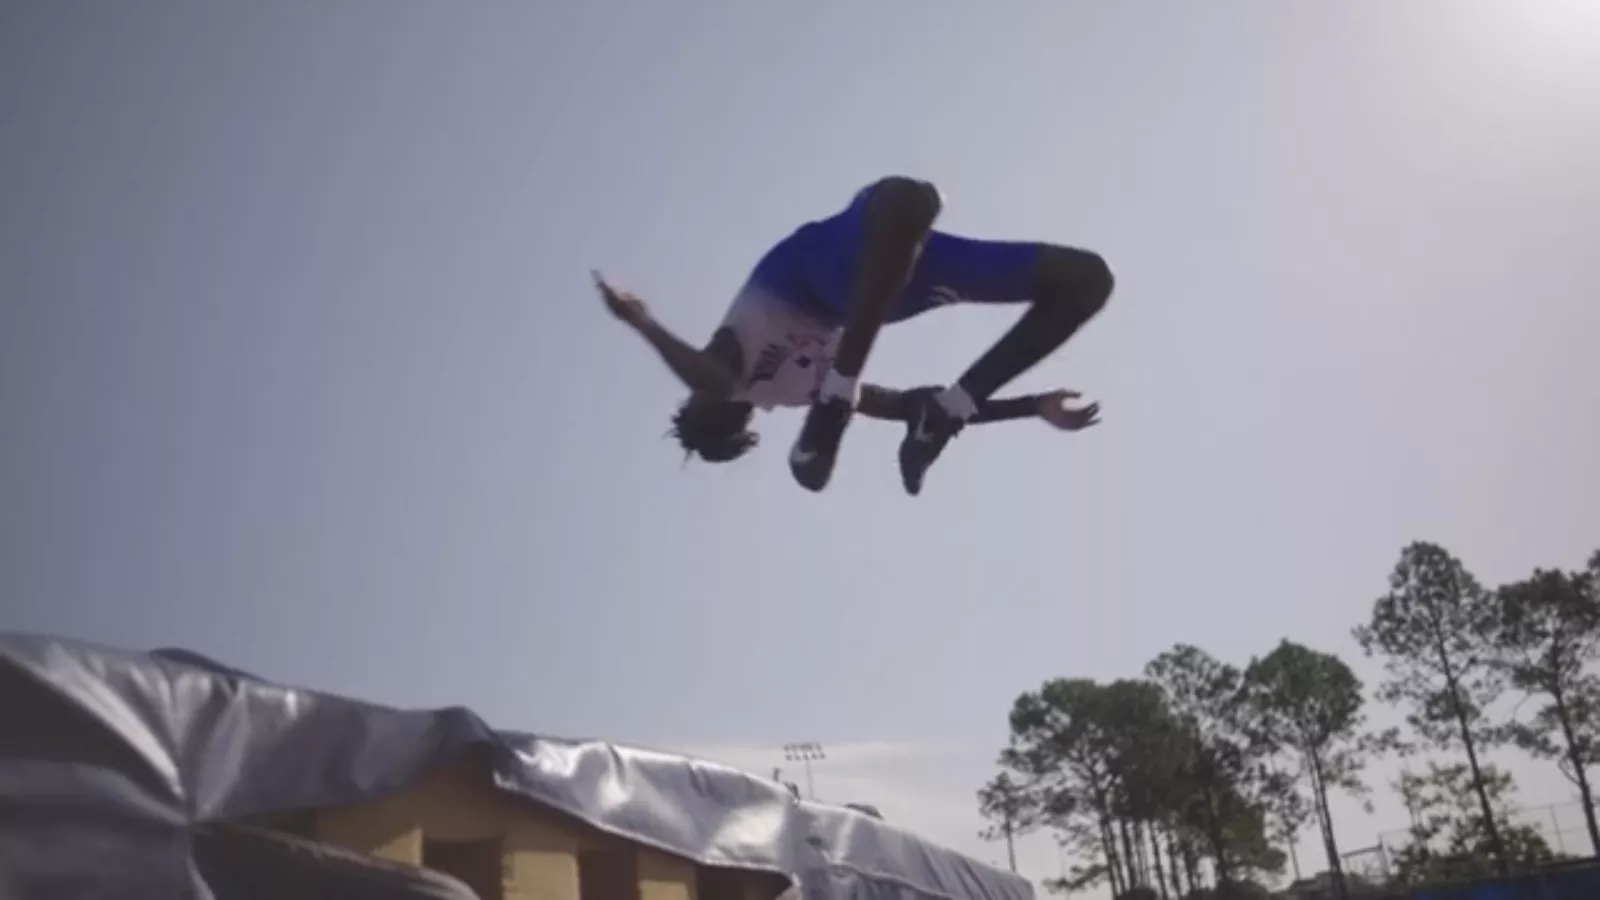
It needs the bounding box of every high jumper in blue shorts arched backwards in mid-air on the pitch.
[595,176,1114,495]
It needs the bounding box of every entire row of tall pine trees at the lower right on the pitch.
[979,543,1600,900]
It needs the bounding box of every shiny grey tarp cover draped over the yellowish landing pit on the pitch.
[0,634,1032,900]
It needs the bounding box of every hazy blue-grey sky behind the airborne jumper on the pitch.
[0,0,1600,879]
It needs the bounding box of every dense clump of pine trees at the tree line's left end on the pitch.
[1004,645,1285,889]
